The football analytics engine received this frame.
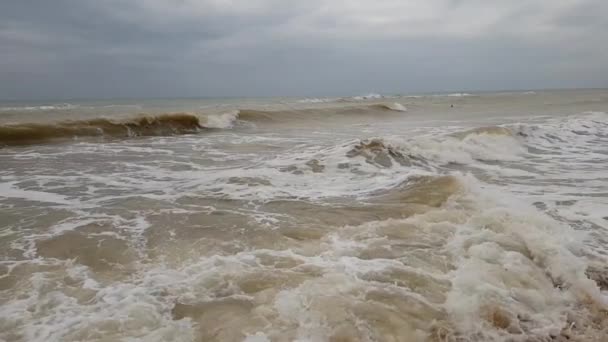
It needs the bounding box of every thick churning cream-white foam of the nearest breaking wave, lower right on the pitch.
[446,177,608,340]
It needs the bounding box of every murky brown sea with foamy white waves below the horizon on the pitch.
[0,90,608,342]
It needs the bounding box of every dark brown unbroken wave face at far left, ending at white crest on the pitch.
[0,113,206,146]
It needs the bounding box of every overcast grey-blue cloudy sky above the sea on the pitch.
[0,0,608,99]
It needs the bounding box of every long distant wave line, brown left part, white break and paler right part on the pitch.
[0,103,406,146]
